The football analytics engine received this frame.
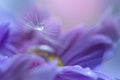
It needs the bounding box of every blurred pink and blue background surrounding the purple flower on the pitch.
[0,0,120,78]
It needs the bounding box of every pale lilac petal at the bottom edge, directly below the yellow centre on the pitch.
[24,62,57,80]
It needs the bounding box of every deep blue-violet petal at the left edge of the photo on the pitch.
[0,24,17,56]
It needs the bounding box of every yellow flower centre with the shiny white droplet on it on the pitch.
[30,45,63,66]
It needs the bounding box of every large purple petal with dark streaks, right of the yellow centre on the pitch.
[58,25,114,68]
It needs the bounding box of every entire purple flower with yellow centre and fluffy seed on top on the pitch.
[0,5,119,80]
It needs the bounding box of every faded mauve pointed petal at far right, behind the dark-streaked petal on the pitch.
[92,6,120,42]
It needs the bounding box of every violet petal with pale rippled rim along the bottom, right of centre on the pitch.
[55,66,115,80]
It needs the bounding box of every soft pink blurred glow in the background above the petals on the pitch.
[48,0,106,29]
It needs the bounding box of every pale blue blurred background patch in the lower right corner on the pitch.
[101,42,120,78]
